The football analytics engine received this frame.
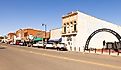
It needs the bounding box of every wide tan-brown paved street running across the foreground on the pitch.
[0,45,121,70]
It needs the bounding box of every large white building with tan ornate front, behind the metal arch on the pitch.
[62,11,121,51]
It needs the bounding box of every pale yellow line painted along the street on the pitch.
[20,50,121,69]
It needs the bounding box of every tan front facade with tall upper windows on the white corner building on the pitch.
[62,13,78,50]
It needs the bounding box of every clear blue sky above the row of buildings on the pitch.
[0,0,121,35]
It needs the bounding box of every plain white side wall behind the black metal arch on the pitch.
[75,12,121,51]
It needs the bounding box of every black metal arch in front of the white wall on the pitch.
[84,28,121,50]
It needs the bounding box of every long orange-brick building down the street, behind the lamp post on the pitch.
[16,28,49,40]
